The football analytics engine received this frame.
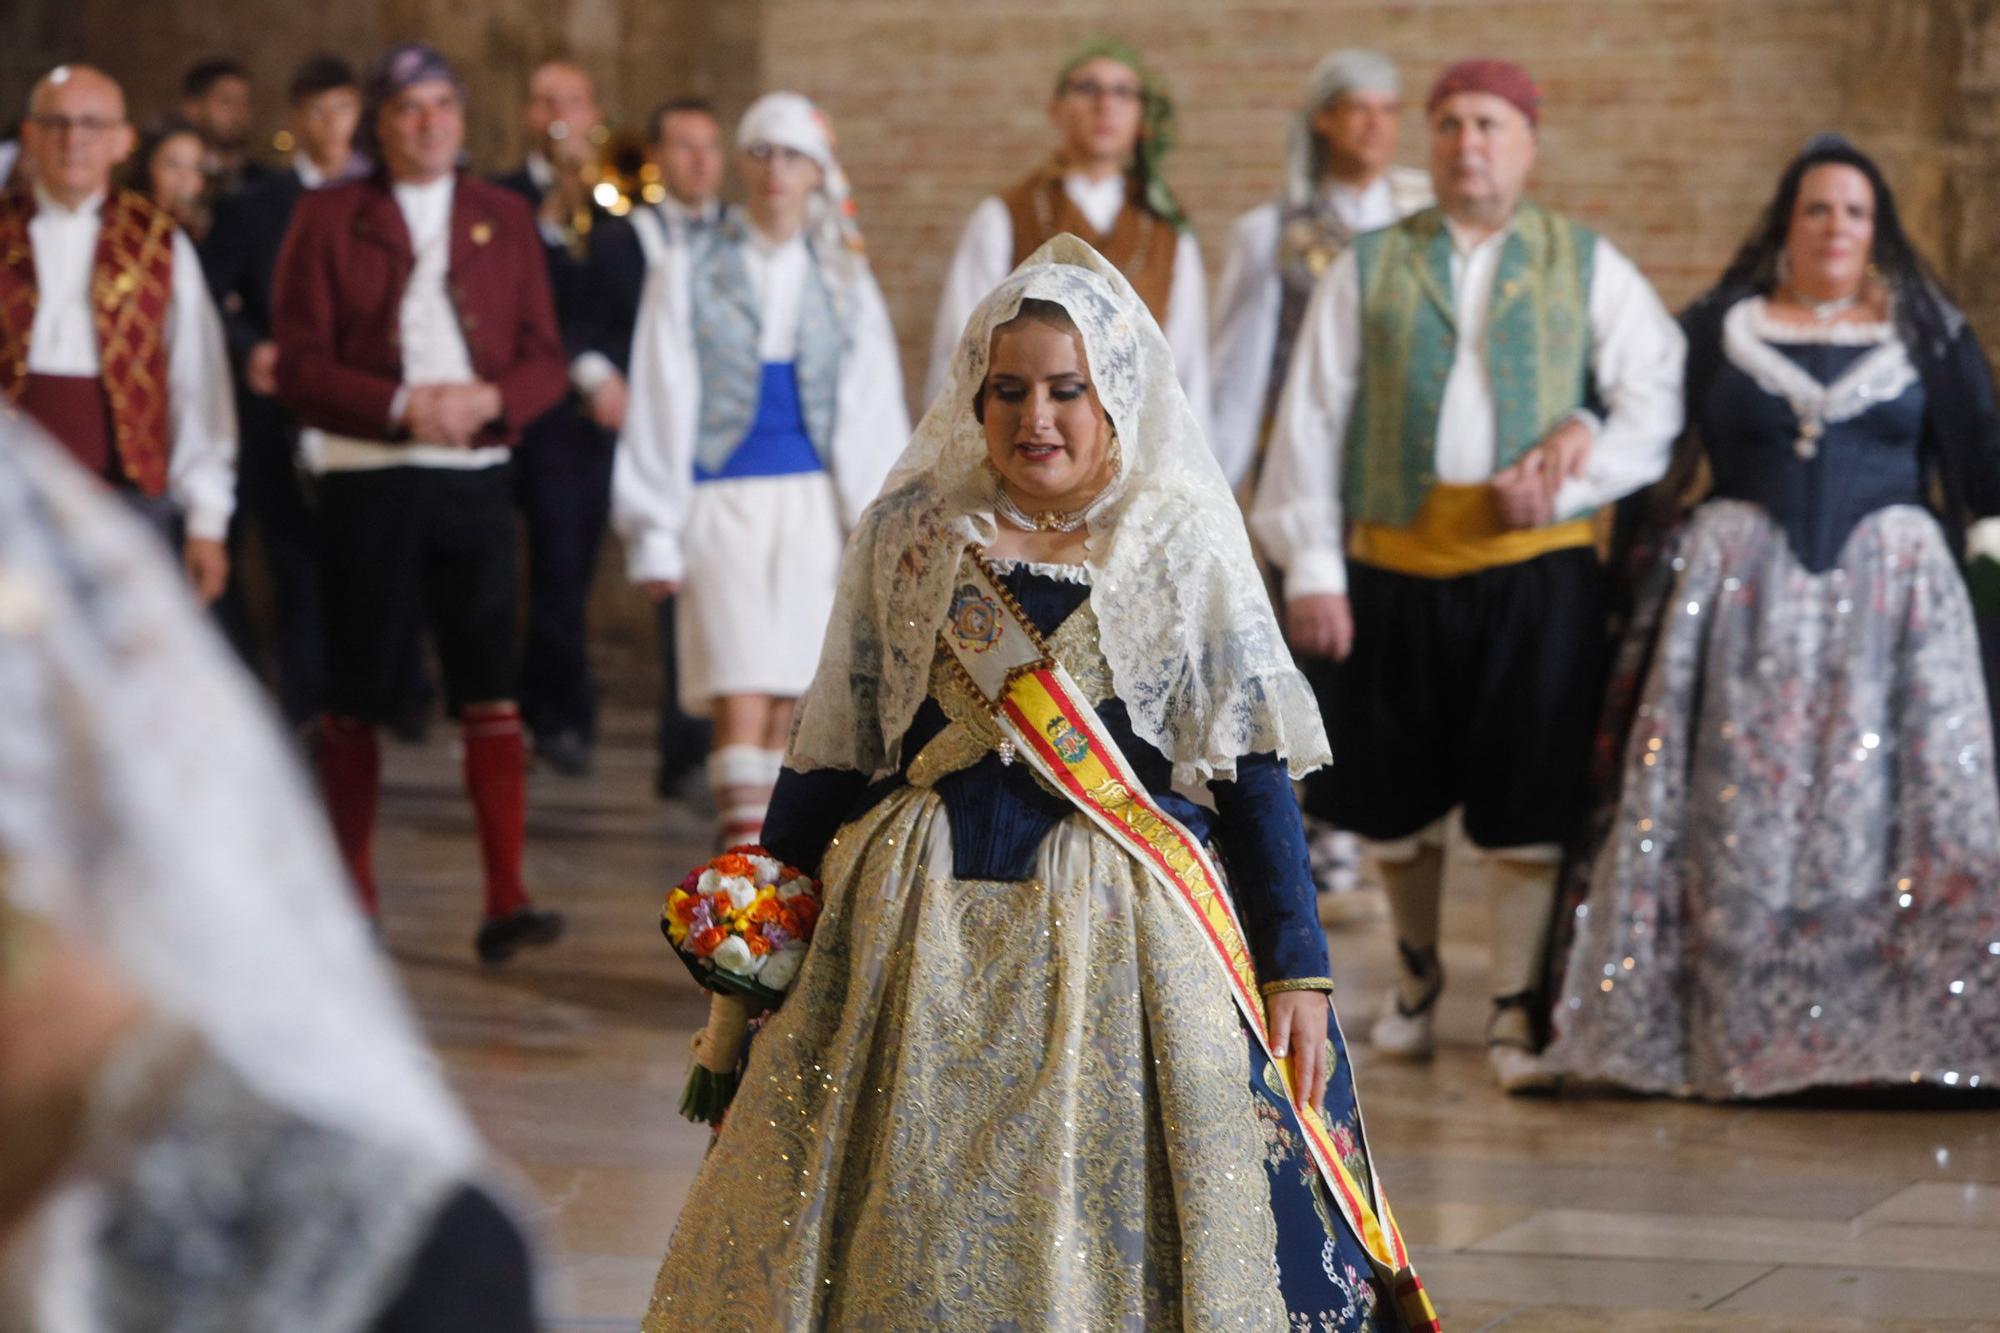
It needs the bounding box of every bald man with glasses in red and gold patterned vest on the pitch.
[0,64,236,600]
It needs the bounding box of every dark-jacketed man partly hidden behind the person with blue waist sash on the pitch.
[570,98,732,799]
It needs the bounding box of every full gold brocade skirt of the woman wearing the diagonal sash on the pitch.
[646,789,1390,1333]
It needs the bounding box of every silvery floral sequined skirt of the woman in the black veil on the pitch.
[1548,500,2000,1099]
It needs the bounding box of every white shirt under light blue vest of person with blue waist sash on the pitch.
[612,226,910,582]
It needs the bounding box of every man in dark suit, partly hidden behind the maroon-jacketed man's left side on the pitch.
[202,56,366,727]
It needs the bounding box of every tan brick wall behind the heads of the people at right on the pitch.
[764,0,1920,400]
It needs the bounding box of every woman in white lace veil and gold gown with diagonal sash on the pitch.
[646,236,1430,1331]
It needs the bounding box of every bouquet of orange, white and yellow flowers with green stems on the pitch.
[660,847,820,1125]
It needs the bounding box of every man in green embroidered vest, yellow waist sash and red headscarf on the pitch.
[1250,60,1684,1091]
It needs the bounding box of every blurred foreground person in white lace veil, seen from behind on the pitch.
[0,420,534,1333]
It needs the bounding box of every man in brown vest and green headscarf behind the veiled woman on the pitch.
[924,42,1208,426]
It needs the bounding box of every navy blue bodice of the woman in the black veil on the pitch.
[1694,332,1924,572]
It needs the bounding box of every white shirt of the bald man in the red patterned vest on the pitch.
[28,186,236,540]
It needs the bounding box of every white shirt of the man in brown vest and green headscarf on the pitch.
[924,172,1210,426]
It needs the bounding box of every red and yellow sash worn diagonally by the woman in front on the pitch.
[938,558,1440,1333]
